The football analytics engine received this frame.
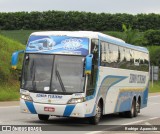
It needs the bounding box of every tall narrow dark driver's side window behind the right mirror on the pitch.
[87,39,99,96]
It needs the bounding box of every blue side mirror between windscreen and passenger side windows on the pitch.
[85,54,93,75]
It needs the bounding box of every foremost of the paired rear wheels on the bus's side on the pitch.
[126,99,137,118]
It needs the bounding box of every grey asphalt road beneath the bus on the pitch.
[0,95,160,134]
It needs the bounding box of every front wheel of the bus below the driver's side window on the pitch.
[89,103,102,125]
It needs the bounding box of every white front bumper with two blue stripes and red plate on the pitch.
[20,99,85,117]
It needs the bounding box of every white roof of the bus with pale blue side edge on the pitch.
[31,31,149,53]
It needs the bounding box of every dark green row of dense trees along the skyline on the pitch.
[0,11,160,31]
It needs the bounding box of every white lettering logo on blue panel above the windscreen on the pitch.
[61,38,82,51]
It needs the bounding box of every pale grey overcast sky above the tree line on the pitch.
[0,0,160,14]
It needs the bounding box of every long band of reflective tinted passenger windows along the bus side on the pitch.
[100,41,149,71]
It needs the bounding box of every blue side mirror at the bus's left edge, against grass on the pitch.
[11,50,24,70]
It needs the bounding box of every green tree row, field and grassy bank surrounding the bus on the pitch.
[0,11,160,101]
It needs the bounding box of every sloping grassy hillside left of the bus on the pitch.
[0,35,25,101]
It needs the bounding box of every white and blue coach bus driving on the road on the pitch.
[12,31,150,124]
